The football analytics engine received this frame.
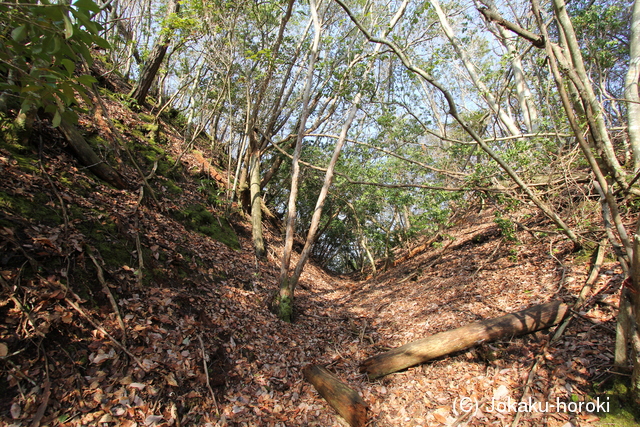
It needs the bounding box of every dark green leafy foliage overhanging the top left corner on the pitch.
[0,0,109,126]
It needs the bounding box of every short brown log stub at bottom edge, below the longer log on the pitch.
[302,365,367,427]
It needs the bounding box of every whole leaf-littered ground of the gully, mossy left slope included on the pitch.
[0,68,636,427]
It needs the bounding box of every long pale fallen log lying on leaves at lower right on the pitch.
[360,301,569,378]
